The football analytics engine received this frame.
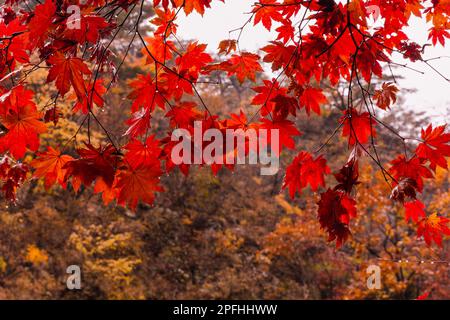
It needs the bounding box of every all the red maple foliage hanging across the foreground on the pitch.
[0,0,450,246]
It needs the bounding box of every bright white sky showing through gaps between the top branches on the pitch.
[177,0,450,123]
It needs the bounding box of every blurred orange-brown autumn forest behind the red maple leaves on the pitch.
[0,8,450,299]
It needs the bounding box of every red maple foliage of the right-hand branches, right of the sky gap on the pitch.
[248,0,450,246]
